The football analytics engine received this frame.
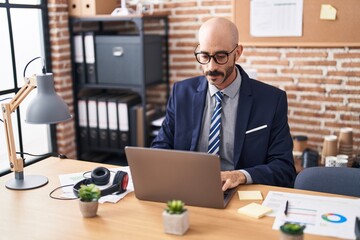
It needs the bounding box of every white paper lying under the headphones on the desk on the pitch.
[59,167,134,203]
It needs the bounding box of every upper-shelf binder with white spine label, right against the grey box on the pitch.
[84,32,96,84]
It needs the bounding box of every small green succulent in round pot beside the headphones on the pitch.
[79,184,101,218]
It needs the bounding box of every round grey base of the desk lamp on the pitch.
[5,175,49,190]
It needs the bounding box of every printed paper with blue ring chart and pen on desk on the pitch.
[263,191,360,239]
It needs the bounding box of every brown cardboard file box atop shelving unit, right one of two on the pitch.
[80,0,119,16]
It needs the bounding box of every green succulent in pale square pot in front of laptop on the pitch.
[162,200,189,235]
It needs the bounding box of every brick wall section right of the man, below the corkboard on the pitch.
[242,48,360,153]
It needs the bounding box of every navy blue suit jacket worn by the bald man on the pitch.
[152,65,296,187]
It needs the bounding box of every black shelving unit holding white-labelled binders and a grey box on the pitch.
[69,15,169,163]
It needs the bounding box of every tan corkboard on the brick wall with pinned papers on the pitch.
[232,0,360,47]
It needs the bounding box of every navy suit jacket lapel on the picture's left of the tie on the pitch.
[190,77,207,151]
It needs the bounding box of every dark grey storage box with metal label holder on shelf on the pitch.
[95,35,163,86]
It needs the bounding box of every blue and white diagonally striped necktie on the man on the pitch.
[208,91,224,155]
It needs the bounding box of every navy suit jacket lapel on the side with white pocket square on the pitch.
[233,67,253,167]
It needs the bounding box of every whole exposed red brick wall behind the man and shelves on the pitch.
[49,0,360,159]
